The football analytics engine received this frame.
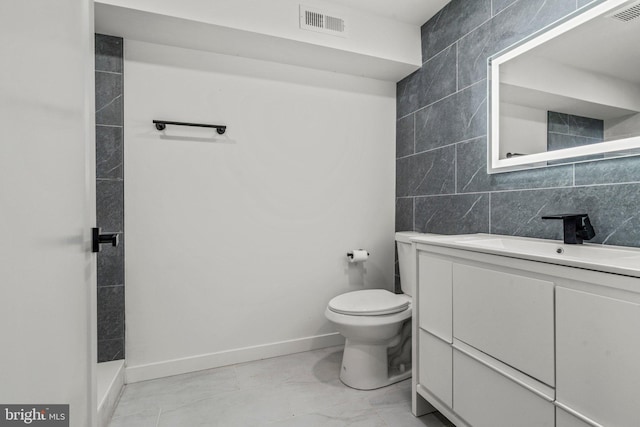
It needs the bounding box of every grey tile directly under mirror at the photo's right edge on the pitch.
[575,156,640,185]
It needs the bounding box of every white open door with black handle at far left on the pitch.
[0,0,96,427]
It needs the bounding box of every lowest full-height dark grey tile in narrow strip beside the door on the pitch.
[97,286,124,341]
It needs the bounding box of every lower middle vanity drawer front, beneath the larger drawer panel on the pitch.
[453,349,555,427]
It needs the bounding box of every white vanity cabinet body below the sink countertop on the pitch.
[413,236,640,427]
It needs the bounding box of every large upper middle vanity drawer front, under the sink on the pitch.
[453,263,555,386]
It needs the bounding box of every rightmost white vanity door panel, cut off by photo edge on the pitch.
[556,288,640,427]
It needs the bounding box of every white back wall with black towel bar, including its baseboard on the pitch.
[124,40,395,381]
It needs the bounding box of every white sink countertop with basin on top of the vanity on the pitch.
[412,234,640,277]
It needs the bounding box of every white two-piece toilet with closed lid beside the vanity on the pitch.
[325,232,420,390]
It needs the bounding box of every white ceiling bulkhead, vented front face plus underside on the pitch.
[96,0,424,82]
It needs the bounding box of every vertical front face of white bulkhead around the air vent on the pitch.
[98,0,420,66]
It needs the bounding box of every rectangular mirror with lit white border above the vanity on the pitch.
[487,0,640,173]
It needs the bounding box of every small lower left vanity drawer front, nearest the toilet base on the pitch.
[418,330,453,407]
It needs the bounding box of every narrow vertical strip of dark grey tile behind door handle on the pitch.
[95,34,124,362]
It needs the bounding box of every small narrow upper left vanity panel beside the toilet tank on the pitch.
[418,251,452,343]
